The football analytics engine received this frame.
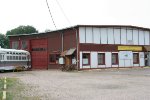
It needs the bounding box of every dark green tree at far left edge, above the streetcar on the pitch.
[0,33,9,48]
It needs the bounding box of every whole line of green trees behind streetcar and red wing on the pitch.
[0,25,38,48]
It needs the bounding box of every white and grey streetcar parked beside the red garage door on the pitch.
[0,48,31,71]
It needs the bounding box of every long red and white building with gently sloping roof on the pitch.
[9,25,150,69]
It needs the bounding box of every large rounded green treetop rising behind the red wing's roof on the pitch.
[6,25,38,35]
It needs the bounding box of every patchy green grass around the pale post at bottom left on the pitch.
[0,78,40,100]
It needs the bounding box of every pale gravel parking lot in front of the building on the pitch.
[0,68,150,100]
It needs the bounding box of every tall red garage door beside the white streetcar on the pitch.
[31,39,48,69]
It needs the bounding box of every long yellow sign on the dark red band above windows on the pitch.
[118,46,142,51]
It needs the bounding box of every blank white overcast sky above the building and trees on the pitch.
[0,0,150,34]
